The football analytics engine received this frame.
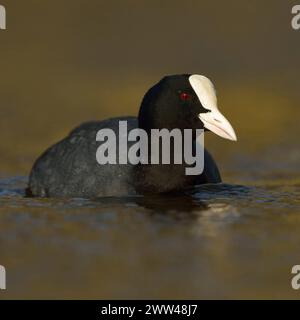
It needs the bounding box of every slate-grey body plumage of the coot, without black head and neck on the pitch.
[27,117,221,198]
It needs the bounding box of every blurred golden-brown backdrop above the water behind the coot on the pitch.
[0,0,300,179]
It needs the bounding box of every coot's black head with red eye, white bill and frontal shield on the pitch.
[138,74,236,140]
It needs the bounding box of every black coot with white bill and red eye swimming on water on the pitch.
[27,74,236,198]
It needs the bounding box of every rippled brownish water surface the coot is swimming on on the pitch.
[0,170,300,298]
